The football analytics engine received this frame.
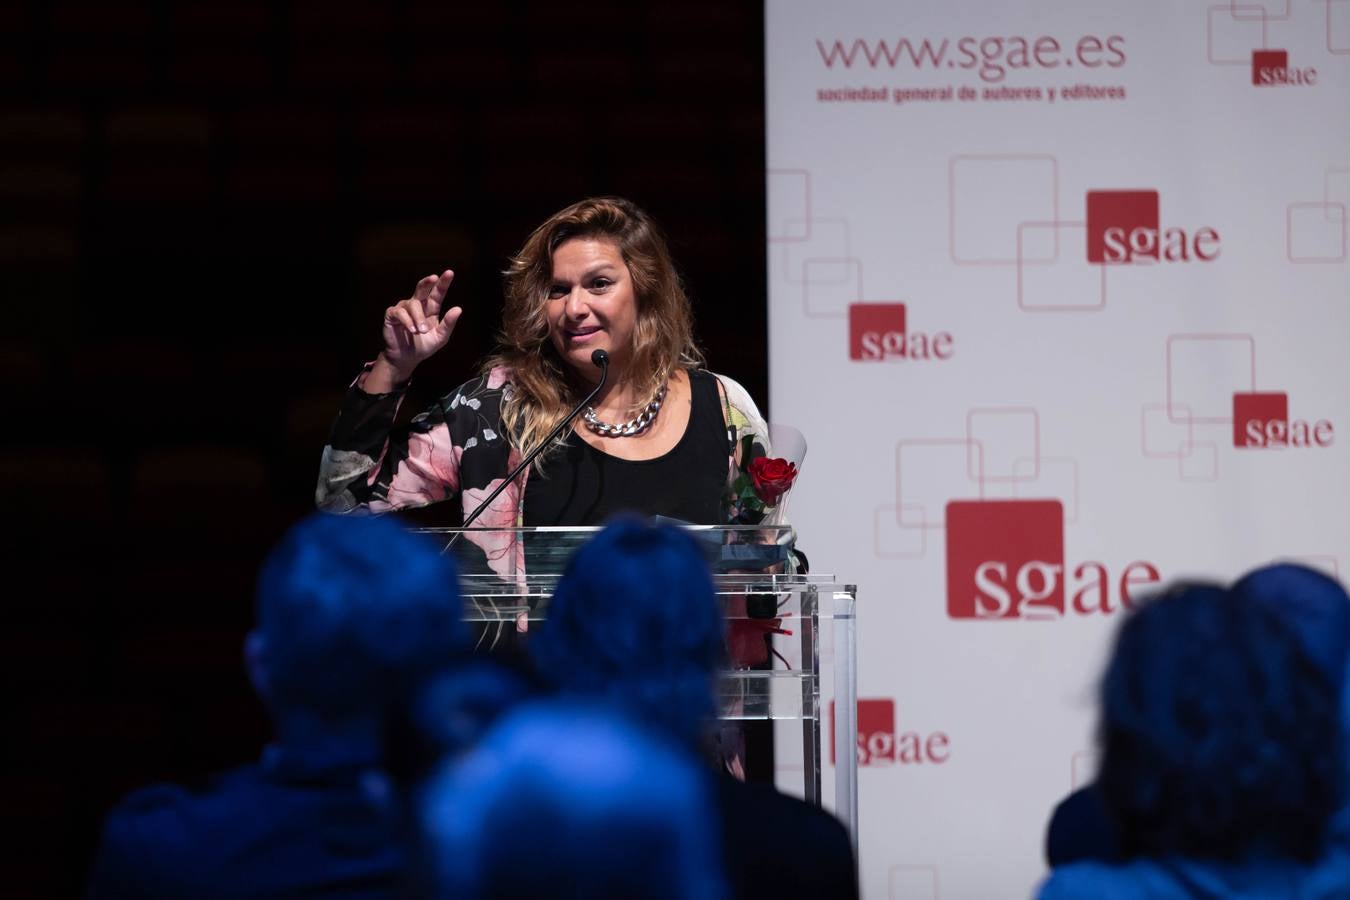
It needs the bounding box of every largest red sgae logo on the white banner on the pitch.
[946,501,1160,619]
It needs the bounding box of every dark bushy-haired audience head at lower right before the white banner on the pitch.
[1099,583,1345,860]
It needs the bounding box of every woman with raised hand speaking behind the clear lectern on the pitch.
[317,197,772,545]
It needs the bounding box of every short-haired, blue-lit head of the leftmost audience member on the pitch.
[247,513,468,723]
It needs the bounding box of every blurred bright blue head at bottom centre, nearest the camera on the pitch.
[419,700,728,900]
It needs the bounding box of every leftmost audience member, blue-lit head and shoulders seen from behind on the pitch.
[89,514,467,899]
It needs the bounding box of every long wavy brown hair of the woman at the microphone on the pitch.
[483,197,703,464]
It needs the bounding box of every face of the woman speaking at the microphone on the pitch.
[544,237,637,381]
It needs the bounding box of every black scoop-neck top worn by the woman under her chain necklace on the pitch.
[524,371,730,525]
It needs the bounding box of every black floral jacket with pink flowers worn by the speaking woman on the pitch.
[315,366,772,571]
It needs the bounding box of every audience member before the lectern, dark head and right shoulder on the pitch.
[529,521,857,900]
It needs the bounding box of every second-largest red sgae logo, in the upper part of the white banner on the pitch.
[1088,190,1219,264]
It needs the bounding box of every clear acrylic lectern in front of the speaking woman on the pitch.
[420,525,857,841]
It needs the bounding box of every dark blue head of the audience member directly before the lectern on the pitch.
[529,519,726,742]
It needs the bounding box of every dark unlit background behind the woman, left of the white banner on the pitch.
[0,0,767,897]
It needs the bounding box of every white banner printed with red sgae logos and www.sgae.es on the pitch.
[765,0,1350,900]
